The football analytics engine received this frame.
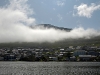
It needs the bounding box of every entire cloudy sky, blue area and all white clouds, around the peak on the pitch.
[0,0,100,43]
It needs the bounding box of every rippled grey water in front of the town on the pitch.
[0,62,100,75]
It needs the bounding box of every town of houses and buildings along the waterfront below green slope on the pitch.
[0,46,100,62]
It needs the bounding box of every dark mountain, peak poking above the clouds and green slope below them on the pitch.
[0,24,100,48]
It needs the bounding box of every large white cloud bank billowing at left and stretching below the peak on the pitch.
[0,0,100,43]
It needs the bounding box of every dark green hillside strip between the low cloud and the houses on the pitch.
[0,36,100,48]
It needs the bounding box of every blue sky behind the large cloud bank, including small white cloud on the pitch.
[0,0,100,29]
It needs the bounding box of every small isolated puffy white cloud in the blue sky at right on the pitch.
[74,3,100,18]
